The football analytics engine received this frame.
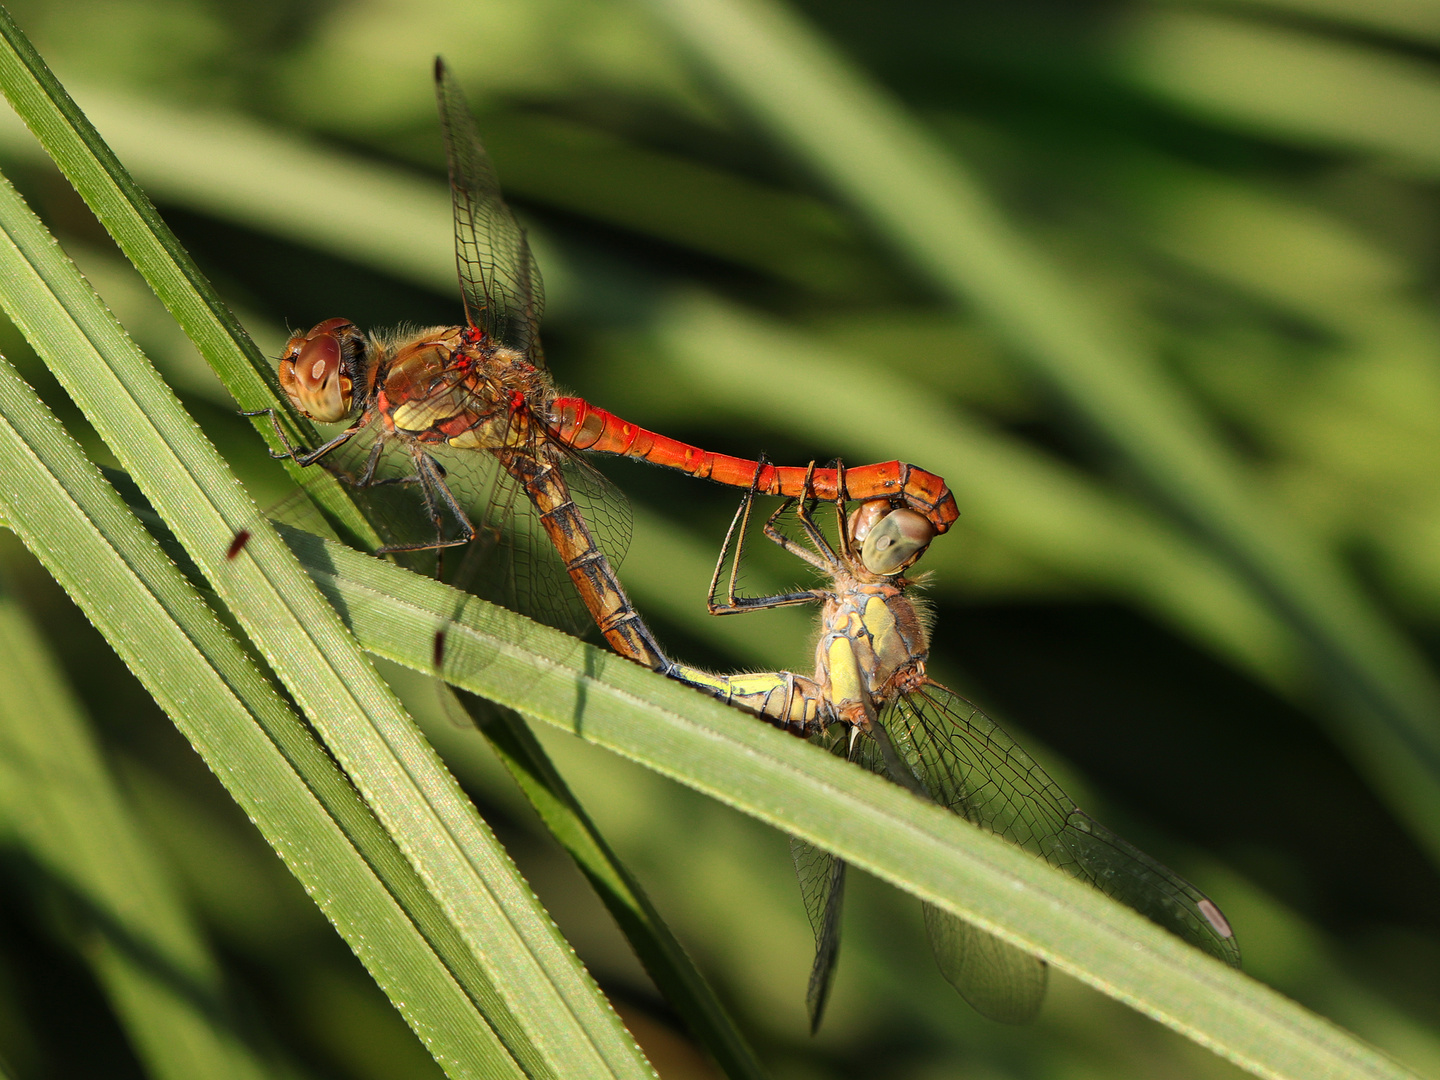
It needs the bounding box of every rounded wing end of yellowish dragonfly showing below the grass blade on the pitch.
[924,904,1050,1024]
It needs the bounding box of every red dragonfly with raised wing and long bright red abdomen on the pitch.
[251,59,958,671]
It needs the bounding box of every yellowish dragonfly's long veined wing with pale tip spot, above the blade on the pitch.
[881,683,1240,966]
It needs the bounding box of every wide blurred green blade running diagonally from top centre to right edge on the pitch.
[651,0,1440,858]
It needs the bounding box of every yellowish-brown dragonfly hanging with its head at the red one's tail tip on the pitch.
[670,480,1240,1030]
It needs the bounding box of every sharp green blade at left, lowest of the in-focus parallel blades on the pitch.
[0,364,517,1077]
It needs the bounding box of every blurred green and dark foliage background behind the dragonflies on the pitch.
[0,0,1440,1080]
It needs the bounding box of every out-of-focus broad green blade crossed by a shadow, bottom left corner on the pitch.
[0,576,294,1080]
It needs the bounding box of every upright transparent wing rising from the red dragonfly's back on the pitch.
[435,59,544,357]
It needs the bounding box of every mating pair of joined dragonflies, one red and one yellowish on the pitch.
[253,60,1238,1027]
